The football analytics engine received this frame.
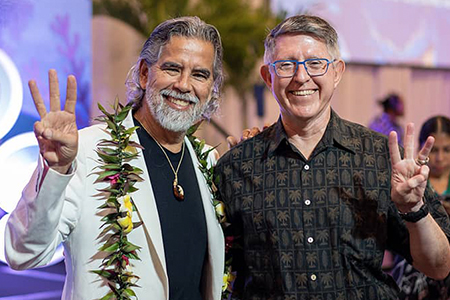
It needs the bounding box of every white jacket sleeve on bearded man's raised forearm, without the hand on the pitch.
[5,159,78,270]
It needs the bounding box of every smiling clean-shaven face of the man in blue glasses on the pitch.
[261,34,345,129]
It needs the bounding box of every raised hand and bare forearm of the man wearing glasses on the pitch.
[389,124,450,279]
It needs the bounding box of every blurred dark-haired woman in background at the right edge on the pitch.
[392,116,450,300]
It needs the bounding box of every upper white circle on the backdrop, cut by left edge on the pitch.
[0,49,23,139]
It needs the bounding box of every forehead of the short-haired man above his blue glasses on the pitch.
[273,34,330,60]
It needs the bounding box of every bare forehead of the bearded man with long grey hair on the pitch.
[158,36,214,70]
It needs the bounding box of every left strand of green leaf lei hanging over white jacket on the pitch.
[92,98,143,300]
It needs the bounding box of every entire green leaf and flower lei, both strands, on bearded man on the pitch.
[92,98,236,300]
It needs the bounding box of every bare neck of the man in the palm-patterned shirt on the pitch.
[282,111,331,159]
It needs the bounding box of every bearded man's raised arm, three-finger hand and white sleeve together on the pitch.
[5,70,78,269]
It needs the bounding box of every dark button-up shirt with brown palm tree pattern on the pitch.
[216,112,450,300]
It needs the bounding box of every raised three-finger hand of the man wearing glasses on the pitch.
[389,123,434,213]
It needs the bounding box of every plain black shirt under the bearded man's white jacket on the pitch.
[135,120,207,300]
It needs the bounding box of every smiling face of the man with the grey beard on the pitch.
[140,36,214,132]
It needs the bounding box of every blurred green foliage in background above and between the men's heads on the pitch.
[93,0,285,93]
